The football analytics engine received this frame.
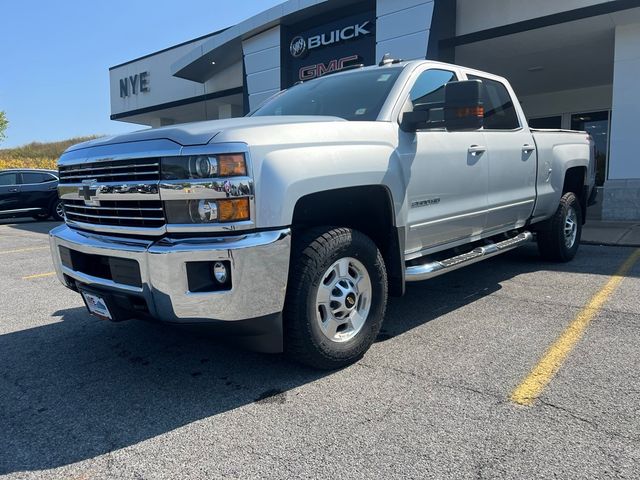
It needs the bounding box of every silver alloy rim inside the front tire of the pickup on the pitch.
[316,257,373,343]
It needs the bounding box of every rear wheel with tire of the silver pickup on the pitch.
[538,192,582,262]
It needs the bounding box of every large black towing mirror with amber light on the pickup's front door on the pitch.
[444,80,484,131]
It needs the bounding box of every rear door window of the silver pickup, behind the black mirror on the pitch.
[467,75,520,130]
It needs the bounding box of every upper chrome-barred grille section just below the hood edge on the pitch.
[59,158,160,184]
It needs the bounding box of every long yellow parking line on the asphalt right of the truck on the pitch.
[510,249,640,406]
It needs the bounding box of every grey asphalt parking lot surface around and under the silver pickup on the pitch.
[0,221,640,479]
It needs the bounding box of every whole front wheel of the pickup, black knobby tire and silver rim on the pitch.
[284,227,388,370]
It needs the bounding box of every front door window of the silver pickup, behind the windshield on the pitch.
[409,69,458,128]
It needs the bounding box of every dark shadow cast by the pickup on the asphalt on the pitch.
[0,244,632,475]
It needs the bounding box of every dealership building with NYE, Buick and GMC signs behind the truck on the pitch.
[109,0,640,220]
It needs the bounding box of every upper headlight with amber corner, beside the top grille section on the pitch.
[162,153,247,180]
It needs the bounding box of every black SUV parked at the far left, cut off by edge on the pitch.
[0,169,64,220]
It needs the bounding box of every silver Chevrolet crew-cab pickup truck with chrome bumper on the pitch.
[50,58,595,369]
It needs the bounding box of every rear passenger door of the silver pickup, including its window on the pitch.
[467,75,536,236]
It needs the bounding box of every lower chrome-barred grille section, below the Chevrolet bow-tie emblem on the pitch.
[63,199,165,228]
